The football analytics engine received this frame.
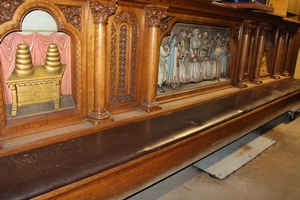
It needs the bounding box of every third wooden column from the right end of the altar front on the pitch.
[251,23,271,84]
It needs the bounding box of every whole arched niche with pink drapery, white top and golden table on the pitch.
[0,10,75,119]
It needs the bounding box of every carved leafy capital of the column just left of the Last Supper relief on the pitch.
[146,6,167,27]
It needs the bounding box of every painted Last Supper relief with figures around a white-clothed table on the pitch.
[158,23,231,93]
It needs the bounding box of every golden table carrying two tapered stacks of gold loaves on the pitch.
[6,43,66,116]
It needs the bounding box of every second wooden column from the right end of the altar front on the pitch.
[271,27,286,79]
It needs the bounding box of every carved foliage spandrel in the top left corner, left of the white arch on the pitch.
[0,0,24,25]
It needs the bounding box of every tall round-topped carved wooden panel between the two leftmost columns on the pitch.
[109,12,139,106]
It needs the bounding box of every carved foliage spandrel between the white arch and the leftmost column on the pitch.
[57,4,82,31]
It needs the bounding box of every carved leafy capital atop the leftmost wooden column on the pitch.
[90,2,117,24]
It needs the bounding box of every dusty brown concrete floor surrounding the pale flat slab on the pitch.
[128,112,300,200]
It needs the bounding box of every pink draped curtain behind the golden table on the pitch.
[0,32,72,104]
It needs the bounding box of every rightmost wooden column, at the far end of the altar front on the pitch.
[282,30,296,76]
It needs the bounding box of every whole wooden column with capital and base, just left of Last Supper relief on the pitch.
[140,5,168,112]
